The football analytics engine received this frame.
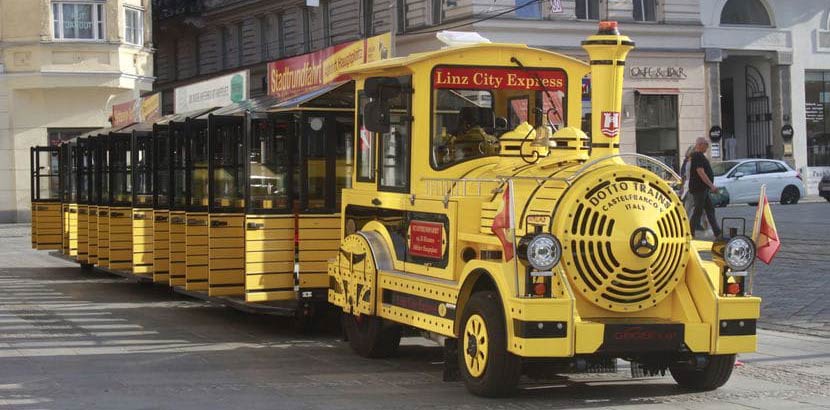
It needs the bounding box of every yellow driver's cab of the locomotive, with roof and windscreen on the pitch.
[343,44,589,280]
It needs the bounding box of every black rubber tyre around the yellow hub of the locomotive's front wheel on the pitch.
[458,291,522,397]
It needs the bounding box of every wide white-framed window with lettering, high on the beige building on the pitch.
[52,2,104,40]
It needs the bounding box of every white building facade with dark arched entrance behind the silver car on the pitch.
[701,0,830,194]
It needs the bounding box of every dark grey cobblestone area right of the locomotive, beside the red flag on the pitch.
[716,201,830,337]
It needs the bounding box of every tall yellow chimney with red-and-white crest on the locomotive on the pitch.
[582,21,634,158]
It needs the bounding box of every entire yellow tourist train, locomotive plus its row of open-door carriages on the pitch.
[32,22,760,397]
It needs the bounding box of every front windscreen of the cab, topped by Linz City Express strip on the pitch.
[431,66,567,169]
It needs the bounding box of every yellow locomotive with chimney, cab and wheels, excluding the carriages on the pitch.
[329,27,760,396]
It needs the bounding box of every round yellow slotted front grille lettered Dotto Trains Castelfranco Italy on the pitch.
[553,165,691,312]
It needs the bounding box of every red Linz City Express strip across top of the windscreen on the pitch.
[432,67,567,92]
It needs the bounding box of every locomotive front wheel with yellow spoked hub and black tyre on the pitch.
[458,291,521,397]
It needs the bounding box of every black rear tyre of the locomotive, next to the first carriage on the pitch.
[341,312,401,359]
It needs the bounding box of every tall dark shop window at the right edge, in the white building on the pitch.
[804,71,830,167]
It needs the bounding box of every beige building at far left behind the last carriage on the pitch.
[0,0,154,222]
